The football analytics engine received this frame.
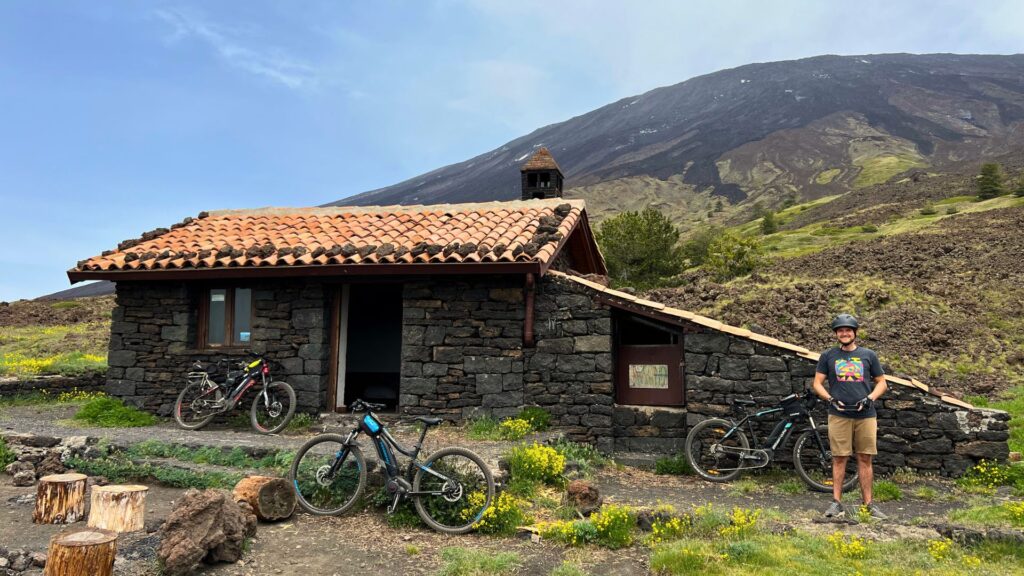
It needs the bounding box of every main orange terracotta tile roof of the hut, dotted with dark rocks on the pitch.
[72,198,586,273]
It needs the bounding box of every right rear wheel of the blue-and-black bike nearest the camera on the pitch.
[413,447,495,534]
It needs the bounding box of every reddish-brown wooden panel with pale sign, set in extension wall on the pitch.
[615,344,685,406]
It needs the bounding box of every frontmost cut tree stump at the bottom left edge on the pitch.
[43,528,118,576]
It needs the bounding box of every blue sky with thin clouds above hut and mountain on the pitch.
[0,0,1024,300]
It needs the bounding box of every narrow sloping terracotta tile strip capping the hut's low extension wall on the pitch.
[548,271,974,410]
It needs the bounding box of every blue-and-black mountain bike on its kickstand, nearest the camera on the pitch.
[289,400,495,534]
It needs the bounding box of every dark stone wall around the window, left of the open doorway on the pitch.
[105,280,329,415]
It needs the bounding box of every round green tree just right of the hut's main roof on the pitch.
[596,208,683,288]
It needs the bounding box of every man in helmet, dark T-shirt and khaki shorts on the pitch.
[814,314,888,520]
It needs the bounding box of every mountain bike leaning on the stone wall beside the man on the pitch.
[684,390,857,492]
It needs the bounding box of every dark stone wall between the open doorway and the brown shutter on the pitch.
[399,276,612,450]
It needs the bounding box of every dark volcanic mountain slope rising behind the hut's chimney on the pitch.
[333,54,1024,205]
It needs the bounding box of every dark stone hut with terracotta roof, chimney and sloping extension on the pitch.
[68,151,1009,476]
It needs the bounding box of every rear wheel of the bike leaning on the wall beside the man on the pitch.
[684,418,751,482]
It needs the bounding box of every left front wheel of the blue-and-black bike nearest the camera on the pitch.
[289,434,367,516]
